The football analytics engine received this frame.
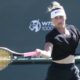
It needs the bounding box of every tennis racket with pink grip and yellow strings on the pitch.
[0,47,39,70]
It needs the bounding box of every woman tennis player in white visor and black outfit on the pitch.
[36,2,80,80]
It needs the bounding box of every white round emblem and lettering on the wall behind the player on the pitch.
[29,19,53,32]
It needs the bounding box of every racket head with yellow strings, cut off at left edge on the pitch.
[0,47,13,71]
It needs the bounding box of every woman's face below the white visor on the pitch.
[52,16,65,28]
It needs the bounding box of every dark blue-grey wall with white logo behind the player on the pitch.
[0,0,80,80]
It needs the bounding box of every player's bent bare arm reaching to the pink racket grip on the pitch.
[36,42,53,58]
